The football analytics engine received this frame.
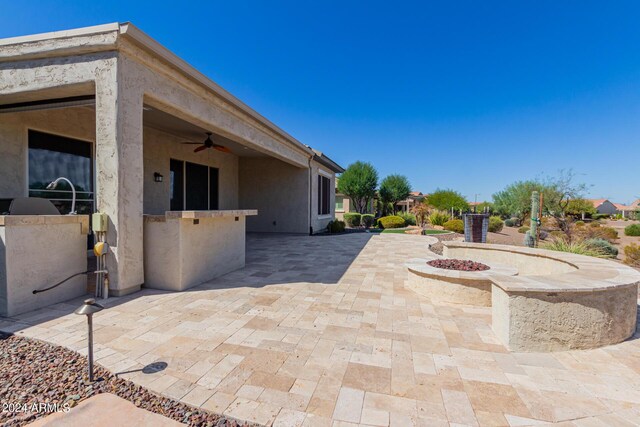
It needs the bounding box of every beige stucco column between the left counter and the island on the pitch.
[95,61,144,296]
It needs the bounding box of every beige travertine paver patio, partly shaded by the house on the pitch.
[0,234,640,426]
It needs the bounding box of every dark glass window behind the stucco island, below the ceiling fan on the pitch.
[169,159,218,211]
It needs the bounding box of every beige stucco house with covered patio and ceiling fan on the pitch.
[0,23,342,315]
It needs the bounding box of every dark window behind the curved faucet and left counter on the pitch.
[29,130,93,215]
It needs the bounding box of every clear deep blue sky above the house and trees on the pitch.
[0,0,640,203]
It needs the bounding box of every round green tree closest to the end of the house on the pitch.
[338,161,378,214]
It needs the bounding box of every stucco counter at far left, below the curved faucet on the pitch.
[0,215,89,316]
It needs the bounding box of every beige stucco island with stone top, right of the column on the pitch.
[144,209,258,291]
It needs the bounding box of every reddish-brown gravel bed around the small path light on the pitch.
[0,332,253,427]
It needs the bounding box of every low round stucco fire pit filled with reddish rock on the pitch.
[405,258,518,307]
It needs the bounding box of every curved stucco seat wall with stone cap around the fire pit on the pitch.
[407,242,640,351]
